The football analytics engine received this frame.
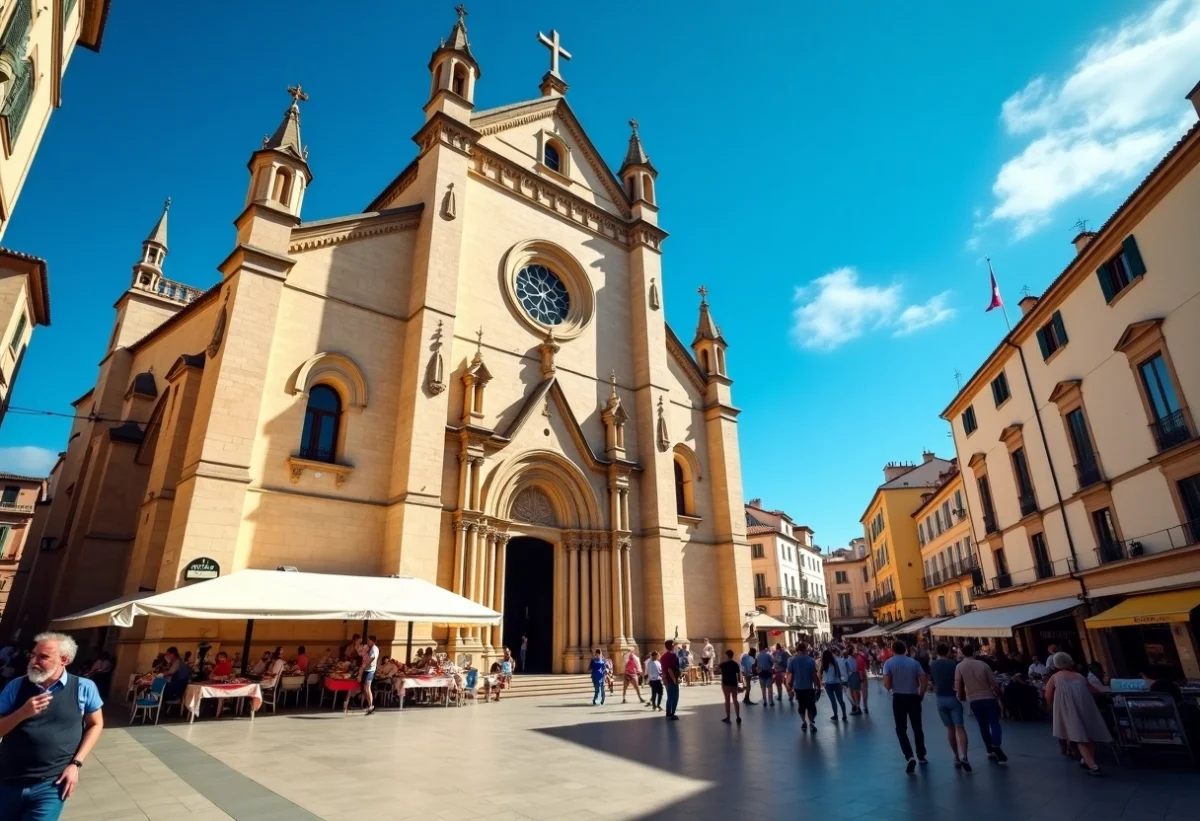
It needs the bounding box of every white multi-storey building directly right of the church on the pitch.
[745,499,829,646]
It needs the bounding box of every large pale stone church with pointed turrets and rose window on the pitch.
[4,11,754,681]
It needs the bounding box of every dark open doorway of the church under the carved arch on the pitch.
[503,537,554,673]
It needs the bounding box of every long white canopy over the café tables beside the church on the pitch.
[50,570,500,630]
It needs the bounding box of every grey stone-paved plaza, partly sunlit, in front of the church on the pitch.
[64,682,1200,821]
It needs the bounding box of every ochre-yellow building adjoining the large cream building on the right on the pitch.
[912,463,979,616]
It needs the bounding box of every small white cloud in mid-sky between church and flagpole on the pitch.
[792,268,954,350]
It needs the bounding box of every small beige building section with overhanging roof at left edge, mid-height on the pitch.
[0,248,50,425]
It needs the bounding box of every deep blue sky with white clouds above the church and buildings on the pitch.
[0,0,1200,546]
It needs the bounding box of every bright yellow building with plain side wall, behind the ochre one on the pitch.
[859,453,950,624]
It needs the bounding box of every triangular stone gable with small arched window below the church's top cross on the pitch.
[470,97,630,220]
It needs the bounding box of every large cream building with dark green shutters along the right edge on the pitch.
[935,85,1200,677]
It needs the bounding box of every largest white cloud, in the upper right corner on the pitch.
[988,0,1200,237]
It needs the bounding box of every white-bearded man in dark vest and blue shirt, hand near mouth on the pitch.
[0,633,104,821]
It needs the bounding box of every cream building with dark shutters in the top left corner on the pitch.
[0,0,112,239]
